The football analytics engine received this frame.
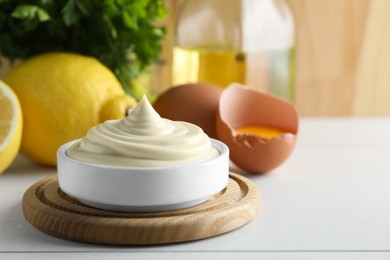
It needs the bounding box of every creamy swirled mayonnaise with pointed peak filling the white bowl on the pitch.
[67,96,219,167]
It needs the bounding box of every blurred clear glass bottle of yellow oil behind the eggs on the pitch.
[172,0,295,101]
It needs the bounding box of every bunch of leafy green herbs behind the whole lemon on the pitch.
[0,0,167,94]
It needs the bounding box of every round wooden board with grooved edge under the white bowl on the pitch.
[23,173,260,245]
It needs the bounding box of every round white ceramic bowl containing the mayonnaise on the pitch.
[57,139,229,212]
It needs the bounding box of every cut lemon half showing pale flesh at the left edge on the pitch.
[0,81,22,173]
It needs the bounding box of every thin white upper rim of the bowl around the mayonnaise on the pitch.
[57,138,229,172]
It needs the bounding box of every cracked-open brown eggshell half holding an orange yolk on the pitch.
[216,83,299,174]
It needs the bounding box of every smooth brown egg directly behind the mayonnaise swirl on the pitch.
[153,83,223,138]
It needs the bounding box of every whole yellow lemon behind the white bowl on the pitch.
[4,53,136,165]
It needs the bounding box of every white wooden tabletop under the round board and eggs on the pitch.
[0,118,390,260]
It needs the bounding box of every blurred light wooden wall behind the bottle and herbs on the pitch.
[0,0,390,116]
